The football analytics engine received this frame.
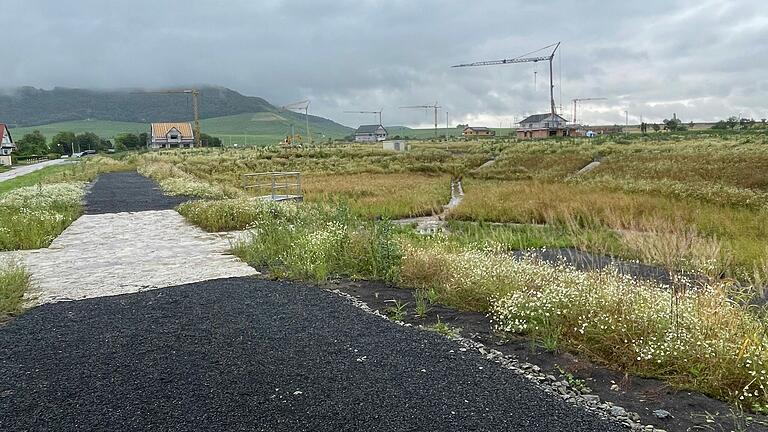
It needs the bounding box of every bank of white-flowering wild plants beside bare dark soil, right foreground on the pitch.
[401,240,768,410]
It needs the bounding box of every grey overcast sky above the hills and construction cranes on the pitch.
[0,0,768,126]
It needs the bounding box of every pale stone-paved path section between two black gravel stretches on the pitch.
[12,210,258,303]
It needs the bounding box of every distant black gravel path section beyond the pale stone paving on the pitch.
[85,171,190,214]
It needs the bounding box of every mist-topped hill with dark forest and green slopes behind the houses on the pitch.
[0,87,354,144]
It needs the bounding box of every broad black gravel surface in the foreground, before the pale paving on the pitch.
[0,278,624,432]
